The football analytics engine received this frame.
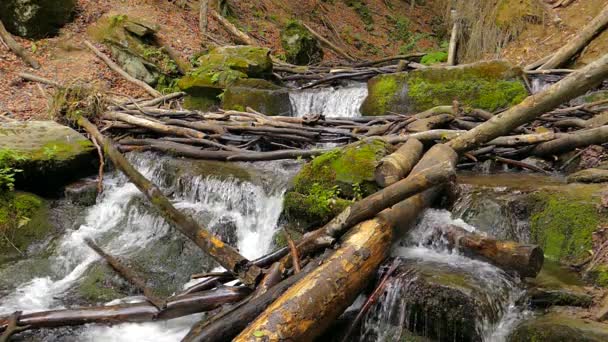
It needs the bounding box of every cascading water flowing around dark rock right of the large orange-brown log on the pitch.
[361,209,527,342]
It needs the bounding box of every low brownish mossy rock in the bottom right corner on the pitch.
[508,312,608,342]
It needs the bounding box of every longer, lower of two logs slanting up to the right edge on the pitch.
[448,54,608,152]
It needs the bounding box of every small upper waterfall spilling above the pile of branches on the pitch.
[289,83,367,117]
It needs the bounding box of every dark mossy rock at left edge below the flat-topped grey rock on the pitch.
[0,191,52,264]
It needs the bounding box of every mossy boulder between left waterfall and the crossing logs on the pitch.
[283,140,390,231]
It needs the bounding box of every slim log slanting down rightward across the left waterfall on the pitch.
[78,117,262,286]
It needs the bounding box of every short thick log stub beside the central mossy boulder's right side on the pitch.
[375,139,424,188]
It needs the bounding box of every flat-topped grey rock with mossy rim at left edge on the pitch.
[0,121,97,194]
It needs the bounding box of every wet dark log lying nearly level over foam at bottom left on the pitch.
[0,286,251,331]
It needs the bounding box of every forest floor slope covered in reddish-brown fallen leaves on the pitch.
[0,0,608,120]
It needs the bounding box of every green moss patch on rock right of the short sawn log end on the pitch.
[530,191,606,261]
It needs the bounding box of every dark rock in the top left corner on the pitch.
[0,0,76,38]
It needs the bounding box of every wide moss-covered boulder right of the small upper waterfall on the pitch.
[361,61,528,115]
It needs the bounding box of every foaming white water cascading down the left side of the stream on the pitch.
[0,153,289,341]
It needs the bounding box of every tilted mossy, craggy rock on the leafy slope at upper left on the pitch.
[89,15,179,90]
